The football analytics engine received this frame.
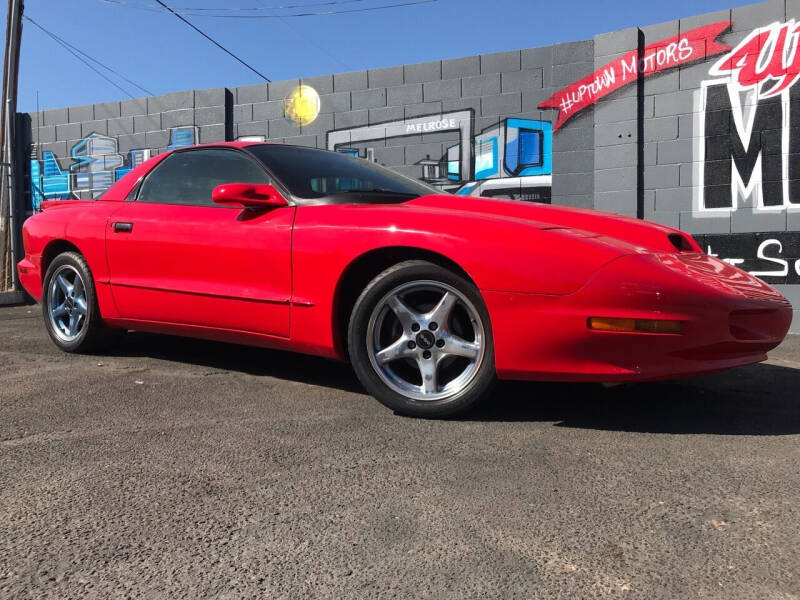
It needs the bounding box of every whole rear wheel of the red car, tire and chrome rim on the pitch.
[42,252,124,352]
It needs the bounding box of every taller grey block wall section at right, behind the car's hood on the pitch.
[588,0,800,331]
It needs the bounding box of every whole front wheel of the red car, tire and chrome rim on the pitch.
[348,261,495,417]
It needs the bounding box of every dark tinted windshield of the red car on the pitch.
[247,144,442,203]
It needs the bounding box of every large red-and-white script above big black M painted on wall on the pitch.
[696,20,800,212]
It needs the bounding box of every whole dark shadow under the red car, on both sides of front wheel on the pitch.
[114,332,800,435]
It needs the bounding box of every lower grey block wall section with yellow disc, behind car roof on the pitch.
[26,41,593,207]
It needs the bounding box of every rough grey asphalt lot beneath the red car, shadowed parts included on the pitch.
[0,307,800,600]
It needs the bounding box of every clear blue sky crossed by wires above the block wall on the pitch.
[9,0,748,111]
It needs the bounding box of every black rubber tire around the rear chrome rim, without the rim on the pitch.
[42,252,125,353]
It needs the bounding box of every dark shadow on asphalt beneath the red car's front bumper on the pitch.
[463,364,800,435]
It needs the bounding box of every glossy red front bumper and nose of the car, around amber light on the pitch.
[482,254,792,381]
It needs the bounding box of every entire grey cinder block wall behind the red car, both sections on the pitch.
[23,0,800,330]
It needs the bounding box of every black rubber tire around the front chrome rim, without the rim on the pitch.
[348,260,495,418]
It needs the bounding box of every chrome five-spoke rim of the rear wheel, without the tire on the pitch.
[47,265,89,342]
